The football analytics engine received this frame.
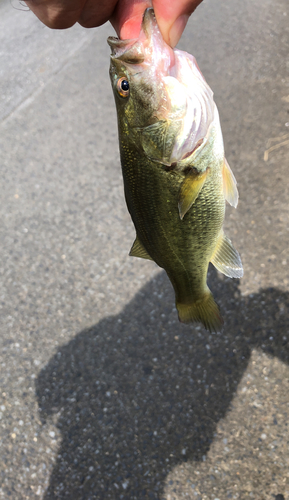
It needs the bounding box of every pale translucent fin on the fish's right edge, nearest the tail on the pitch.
[211,232,243,278]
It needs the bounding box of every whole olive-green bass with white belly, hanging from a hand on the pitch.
[108,8,243,331]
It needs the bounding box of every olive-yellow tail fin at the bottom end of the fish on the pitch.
[177,291,224,332]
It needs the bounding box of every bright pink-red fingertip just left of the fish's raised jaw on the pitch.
[110,0,151,40]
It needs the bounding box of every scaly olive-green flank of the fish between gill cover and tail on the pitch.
[121,135,225,308]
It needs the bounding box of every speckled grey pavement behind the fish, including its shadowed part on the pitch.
[0,0,289,500]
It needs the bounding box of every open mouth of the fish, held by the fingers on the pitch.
[107,7,161,64]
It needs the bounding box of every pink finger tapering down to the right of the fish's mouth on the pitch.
[153,0,202,47]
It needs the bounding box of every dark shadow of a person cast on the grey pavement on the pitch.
[36,270,289,500]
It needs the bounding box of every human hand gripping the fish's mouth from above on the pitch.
[26,0,202,47]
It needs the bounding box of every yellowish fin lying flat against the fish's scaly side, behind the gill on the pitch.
[178,169,208,219]
